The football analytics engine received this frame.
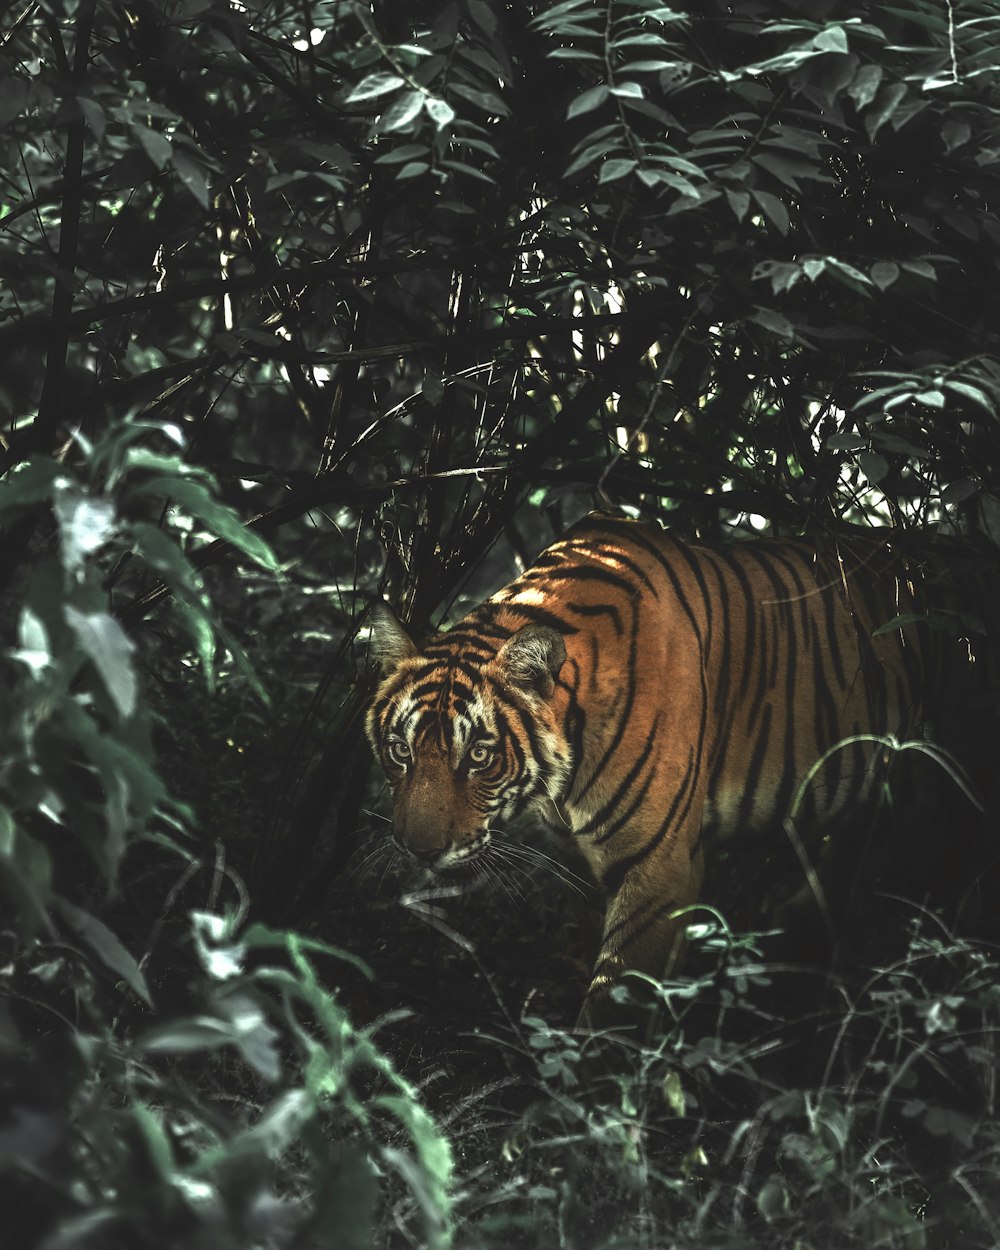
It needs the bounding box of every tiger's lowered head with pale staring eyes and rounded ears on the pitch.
[366,604,570,873]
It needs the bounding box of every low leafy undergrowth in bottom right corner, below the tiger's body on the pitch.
[469,926,1000,1250]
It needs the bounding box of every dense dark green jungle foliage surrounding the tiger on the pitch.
[0,0,1000,1250]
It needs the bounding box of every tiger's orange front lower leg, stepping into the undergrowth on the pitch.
[576,838,703,1033]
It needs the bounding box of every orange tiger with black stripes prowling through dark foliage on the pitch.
[366,513,990,1030]
